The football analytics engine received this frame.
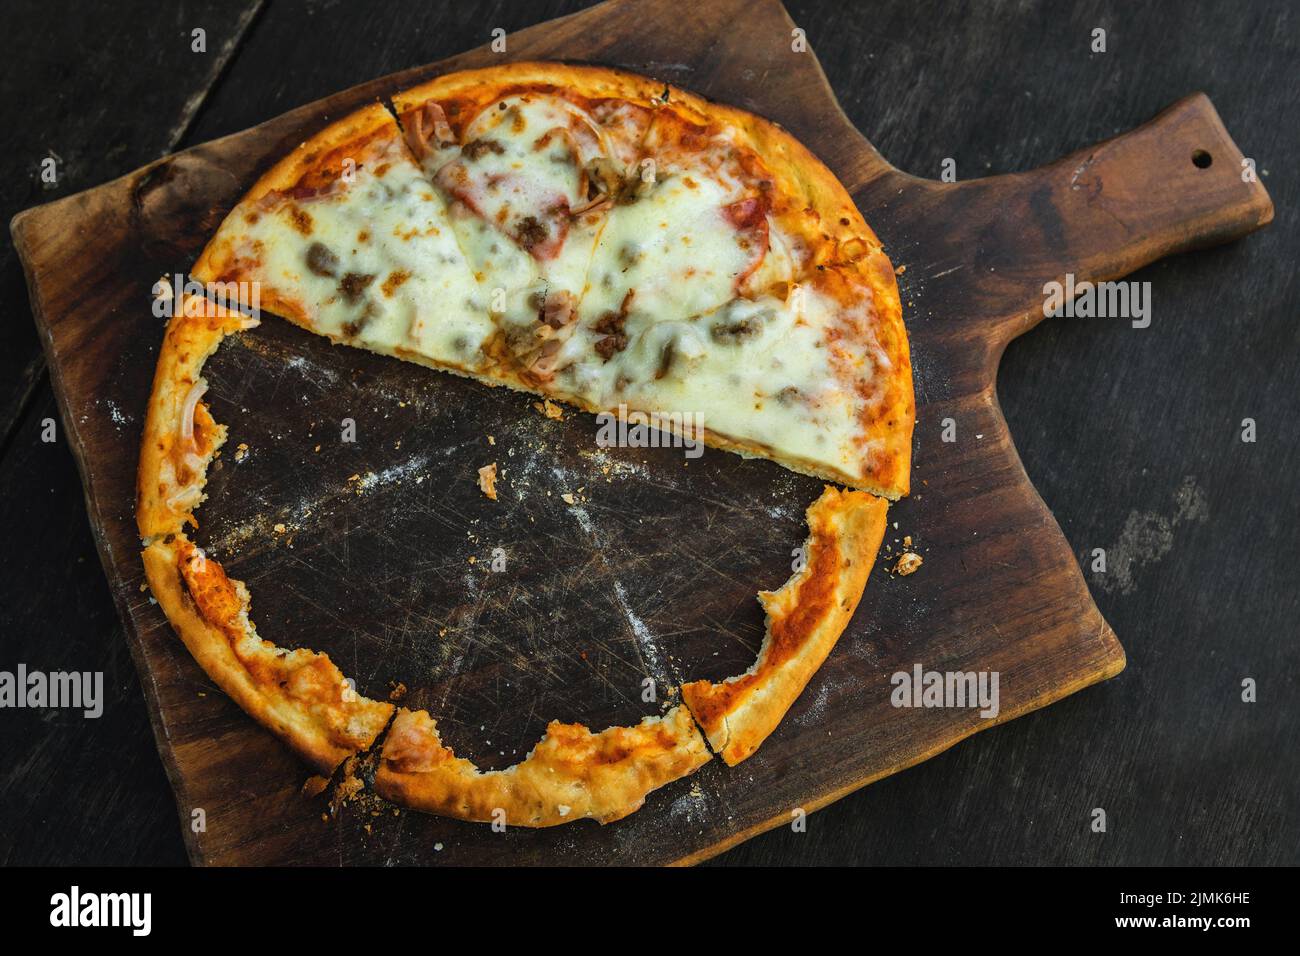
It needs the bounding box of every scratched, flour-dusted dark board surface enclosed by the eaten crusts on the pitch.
[198,317,820,767]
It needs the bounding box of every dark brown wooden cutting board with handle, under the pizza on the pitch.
[13,0,1273,864]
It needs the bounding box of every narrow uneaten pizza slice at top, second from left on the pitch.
[394,79,651,388]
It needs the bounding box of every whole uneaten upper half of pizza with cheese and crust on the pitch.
[194,64,914,498]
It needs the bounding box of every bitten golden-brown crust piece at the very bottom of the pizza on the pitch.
[374,706,710,827]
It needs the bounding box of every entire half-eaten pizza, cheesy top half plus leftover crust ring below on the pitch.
[137,62,914,827]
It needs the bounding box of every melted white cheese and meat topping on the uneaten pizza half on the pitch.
[200,92,888,481]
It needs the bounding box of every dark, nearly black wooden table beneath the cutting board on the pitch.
[0,0,1300,865]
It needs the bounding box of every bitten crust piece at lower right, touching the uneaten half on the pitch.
[681,486,888,766]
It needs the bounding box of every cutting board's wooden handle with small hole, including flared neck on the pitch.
[889,94,1273,348]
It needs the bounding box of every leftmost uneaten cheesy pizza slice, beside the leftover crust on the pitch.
[192,103,495,373]
